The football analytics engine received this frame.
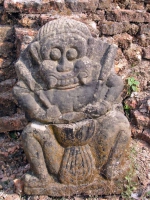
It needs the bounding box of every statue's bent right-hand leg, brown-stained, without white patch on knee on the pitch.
[91,111,131,179]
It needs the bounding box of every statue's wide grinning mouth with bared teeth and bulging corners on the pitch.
[48,72,88,89]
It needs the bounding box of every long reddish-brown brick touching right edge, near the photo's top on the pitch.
[106,9,150,22]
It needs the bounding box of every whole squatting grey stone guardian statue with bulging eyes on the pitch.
[13,18,130,196]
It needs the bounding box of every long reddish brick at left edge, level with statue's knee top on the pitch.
[0,114,27,133]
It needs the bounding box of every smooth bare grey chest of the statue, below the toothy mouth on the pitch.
[44,82,97,113]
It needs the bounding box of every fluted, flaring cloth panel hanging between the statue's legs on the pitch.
[59,145,95,185]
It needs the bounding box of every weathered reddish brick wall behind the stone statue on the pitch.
[0,0,150,132]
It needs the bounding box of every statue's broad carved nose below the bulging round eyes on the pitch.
[57,58,73,72]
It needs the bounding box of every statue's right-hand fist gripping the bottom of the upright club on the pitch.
[84,100,111,118]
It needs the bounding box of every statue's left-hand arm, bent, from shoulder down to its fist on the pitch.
[13,81,61,123]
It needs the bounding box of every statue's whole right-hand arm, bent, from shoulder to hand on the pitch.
[84,72,123,118]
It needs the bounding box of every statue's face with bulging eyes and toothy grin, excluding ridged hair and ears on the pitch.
[29,34,99,89]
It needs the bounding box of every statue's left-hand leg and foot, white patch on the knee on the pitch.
[22,123,64,187]
